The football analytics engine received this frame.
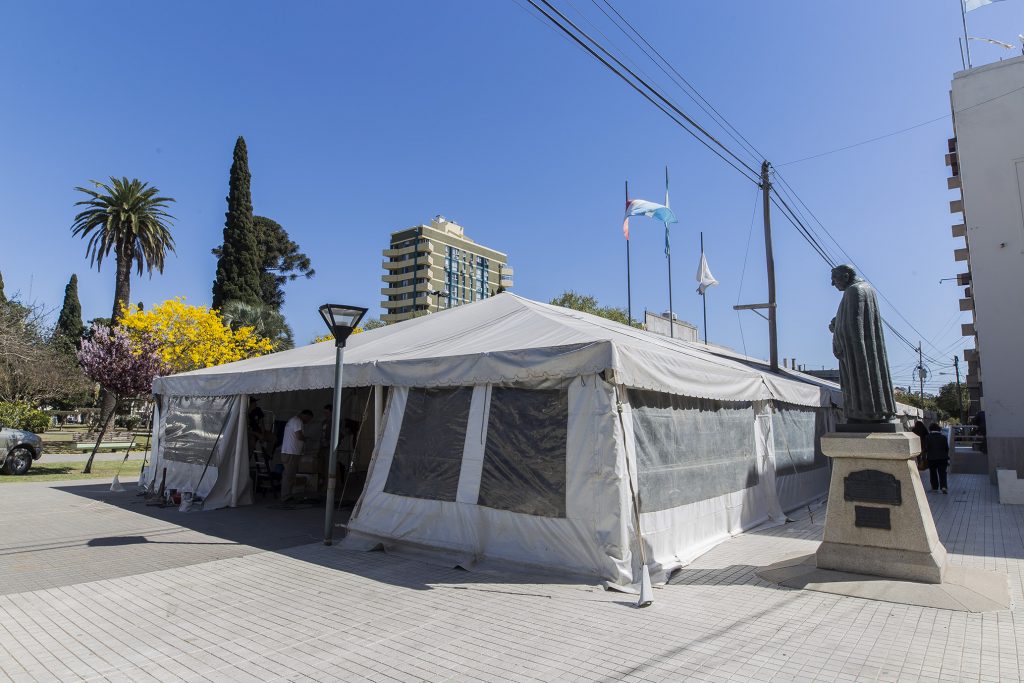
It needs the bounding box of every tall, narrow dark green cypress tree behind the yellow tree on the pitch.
[213,135,262,308]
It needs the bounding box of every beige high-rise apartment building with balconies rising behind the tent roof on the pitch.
[381,216,512,323]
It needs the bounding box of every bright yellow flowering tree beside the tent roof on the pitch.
[120,297,273,373]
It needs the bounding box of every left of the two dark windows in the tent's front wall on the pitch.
[384,387,473,502]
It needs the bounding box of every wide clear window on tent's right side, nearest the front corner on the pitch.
[629,390,759,512]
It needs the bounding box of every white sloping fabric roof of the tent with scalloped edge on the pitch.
[154,292,842,405]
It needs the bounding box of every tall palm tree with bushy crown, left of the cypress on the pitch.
[71,177,174,326]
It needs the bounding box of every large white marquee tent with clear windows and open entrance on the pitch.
[151,293,841,584]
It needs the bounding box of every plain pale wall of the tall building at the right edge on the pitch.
[952,57,1024,471]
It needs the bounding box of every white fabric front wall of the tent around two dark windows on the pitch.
[346,375,631,583]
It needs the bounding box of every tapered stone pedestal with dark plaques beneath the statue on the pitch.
[816,432,946,584]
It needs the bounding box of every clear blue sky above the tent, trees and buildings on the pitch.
[0,0,1024,385]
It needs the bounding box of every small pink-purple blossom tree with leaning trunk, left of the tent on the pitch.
[78,326,167,474]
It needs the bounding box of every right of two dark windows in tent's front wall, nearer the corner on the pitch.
[477,387,569,517]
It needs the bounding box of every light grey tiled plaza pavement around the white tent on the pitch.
[0,475,1024,681]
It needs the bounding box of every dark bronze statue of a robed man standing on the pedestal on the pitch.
[828,265,896,423]
